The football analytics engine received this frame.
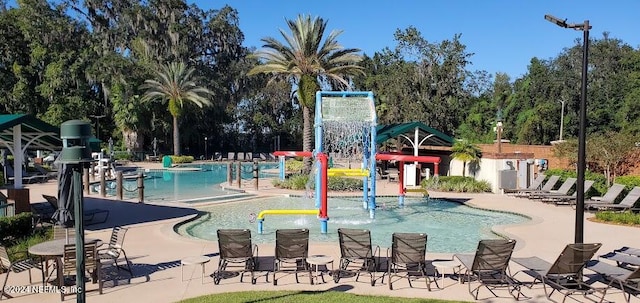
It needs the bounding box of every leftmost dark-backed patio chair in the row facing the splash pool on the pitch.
[213,229,258,285]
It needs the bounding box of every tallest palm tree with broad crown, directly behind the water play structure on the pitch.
[248,15,363,171]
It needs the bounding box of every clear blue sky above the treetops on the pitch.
[188,0,640,80]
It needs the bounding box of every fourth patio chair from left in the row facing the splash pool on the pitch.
[387,233,438,291]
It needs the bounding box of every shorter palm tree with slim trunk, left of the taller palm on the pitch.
[141,62,213,155]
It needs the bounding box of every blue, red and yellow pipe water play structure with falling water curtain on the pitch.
[256,91,440,234]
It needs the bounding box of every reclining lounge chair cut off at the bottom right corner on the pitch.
[586,260,640,303]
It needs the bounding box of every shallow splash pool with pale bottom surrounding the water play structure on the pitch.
[178,197,529,253]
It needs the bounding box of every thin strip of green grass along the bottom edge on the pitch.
[180,291,465,303]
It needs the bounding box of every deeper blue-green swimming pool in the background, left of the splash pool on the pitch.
[107,163,278,203]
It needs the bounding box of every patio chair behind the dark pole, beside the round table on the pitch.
[58,242,103,301]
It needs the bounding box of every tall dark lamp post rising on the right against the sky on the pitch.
[544,15,591,243]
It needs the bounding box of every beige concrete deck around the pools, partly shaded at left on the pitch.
[1,164,640,302]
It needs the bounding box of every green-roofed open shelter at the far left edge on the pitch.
[0,114,62,188]
